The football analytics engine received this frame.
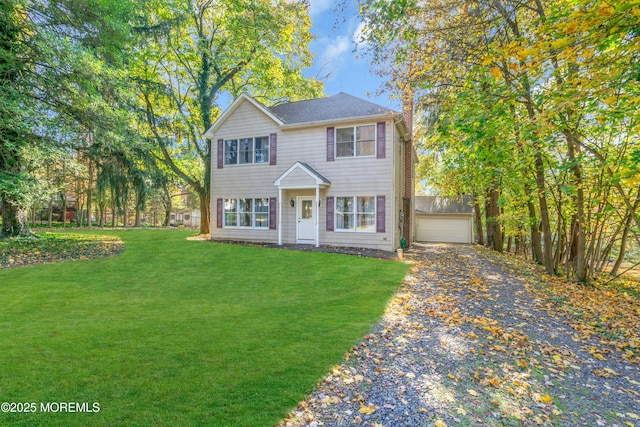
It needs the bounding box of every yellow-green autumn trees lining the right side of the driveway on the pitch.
[360,0,640,281]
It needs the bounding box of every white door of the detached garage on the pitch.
[416,215,472,243]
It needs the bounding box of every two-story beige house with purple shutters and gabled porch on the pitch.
[205,93,415,251]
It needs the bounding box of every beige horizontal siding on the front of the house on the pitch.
[211,98,401,251]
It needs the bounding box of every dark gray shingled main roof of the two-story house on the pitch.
[269,92,395,124]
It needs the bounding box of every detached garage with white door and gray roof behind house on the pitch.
[415,196,474,243]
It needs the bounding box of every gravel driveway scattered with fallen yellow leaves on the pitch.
[280,244,640,427]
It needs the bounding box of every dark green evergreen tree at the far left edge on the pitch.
[0,0,139,236]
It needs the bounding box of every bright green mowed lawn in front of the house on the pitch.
[0,230,407,426]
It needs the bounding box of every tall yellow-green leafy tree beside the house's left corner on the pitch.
[134,0,321,234]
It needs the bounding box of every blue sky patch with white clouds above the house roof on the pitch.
[305,0,400,110]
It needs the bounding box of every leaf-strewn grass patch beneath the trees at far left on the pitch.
[0,233,124,268]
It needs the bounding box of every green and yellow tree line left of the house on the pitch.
[0,0,322,236]
